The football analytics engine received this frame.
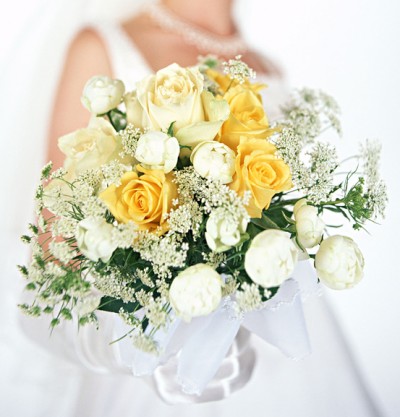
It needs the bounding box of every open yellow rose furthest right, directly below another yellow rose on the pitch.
[230,137,293,218]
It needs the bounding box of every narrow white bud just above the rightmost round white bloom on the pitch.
[293,199,325,248]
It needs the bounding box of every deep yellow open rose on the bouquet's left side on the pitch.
[99,165,178,232]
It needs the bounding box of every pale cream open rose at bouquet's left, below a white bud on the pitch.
[58,117,127,176]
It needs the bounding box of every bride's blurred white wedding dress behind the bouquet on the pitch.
[0,19,381,417]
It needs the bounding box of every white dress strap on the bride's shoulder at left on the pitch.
[91,22,152,90]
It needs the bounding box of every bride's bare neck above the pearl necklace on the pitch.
[161,0,236,36]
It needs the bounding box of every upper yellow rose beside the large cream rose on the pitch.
[218,84,274,151]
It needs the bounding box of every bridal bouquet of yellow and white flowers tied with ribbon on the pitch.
[20,57,387,393]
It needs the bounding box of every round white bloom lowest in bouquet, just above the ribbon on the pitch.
[169,264,222,321]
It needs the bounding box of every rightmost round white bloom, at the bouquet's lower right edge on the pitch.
[315,235,364,290]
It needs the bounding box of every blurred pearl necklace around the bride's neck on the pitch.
[145,3,247,57]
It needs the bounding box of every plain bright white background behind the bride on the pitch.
[0,0,400,417]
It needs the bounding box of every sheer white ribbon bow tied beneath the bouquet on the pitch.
[113,261,320,402]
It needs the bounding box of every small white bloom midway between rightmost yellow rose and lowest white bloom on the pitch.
[205,210,248,252]
